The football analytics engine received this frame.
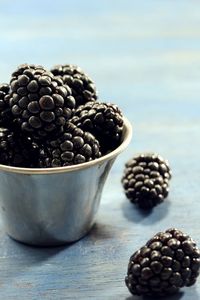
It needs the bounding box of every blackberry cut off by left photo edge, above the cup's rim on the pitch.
[0,83,12,126]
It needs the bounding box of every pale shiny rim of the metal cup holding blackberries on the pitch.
[0,117,132,175]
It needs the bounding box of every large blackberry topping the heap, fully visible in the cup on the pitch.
[9,64,75,139]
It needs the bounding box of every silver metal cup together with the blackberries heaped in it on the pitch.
[0,64,132,246]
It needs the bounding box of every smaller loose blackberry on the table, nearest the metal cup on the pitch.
[122,153,171,209]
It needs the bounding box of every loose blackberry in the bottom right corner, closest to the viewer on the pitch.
[125,229,200,296]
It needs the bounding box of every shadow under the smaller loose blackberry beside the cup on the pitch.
[122,200,171,225]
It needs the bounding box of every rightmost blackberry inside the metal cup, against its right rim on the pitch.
[71,102,124,153]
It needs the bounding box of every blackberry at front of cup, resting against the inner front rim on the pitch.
[39,122,101,168]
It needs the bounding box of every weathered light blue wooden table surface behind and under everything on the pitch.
[0,0,200,300]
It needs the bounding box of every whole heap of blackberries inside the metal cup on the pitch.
[0,64,123,168]
